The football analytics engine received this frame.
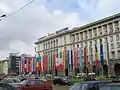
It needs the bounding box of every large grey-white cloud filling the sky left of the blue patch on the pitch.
[0,0,82,59]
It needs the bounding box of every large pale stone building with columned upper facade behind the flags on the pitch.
[35,13,120,75]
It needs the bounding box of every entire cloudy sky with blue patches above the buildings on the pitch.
[0,0,120,60]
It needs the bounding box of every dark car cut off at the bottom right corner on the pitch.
[98,83,120,90]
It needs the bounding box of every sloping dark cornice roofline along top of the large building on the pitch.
[34,13,120,44]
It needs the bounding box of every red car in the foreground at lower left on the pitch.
[15,79,53,90]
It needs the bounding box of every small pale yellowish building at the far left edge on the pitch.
[0,60,8,75]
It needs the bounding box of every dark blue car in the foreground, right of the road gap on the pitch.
[69,81,107,90]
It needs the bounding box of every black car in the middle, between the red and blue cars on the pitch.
[53,77,72,85]
